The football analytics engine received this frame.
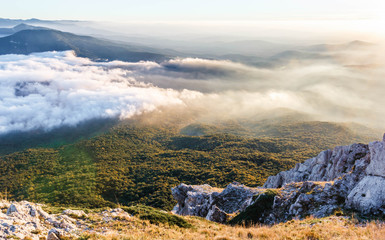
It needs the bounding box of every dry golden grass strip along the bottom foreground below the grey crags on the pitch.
[79,214,385,240]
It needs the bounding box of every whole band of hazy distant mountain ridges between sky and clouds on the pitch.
[0,21,375,68]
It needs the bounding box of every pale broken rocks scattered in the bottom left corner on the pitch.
[0,200,131,240]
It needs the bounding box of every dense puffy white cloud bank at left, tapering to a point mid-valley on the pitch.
[0,52,200,133]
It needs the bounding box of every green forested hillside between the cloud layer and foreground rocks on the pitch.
[0,118,373,210]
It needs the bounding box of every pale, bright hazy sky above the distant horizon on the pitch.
[0,0,385,21]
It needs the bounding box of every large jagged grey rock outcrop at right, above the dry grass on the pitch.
[172,135,385,223]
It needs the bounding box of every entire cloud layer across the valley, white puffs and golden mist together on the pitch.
[0,47,385,134]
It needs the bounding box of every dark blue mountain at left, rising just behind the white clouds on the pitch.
[0,29,170,62]
